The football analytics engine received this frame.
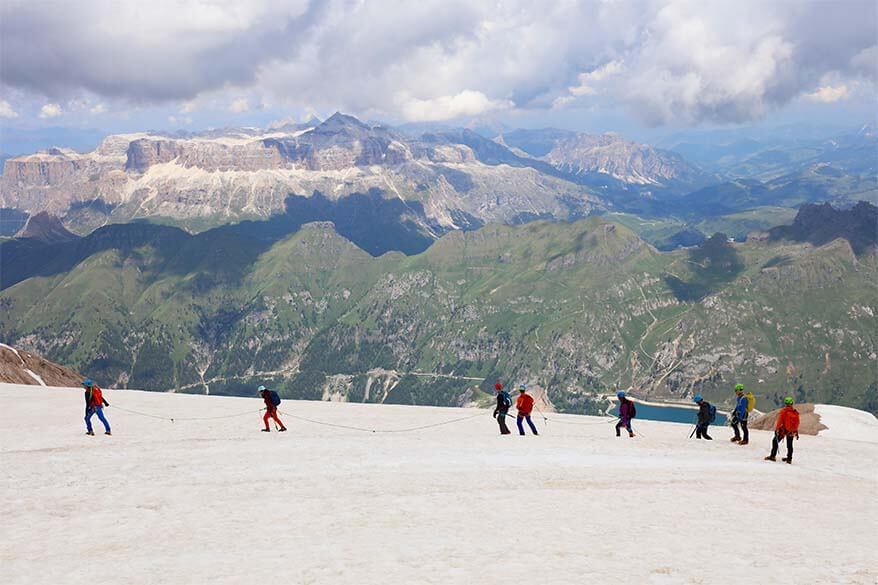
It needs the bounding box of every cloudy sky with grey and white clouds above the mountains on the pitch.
[0,0,878,151]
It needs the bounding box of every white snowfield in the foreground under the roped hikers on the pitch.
[0,384,878,585]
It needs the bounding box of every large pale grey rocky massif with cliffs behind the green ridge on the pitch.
[0,114,601,236]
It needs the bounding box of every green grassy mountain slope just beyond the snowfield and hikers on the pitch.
[0,208,878,412]
